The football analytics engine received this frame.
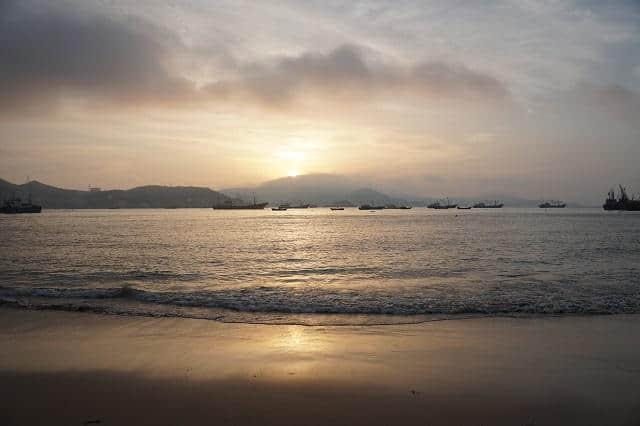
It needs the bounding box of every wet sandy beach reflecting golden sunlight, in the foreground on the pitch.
[0,308,640,425]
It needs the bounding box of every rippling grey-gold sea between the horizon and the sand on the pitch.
[0,208,640,324]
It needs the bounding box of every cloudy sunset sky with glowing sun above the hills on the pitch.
[0,0,640,203]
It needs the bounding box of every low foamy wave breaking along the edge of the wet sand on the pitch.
[0,285,640,324]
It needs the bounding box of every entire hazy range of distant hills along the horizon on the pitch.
[0,174,580,209]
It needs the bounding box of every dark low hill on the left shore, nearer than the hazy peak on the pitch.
[0,179,228,209]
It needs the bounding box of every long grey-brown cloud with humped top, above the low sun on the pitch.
[205,45,508,105]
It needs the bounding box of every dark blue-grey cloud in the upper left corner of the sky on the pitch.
[0,2,194,113]
